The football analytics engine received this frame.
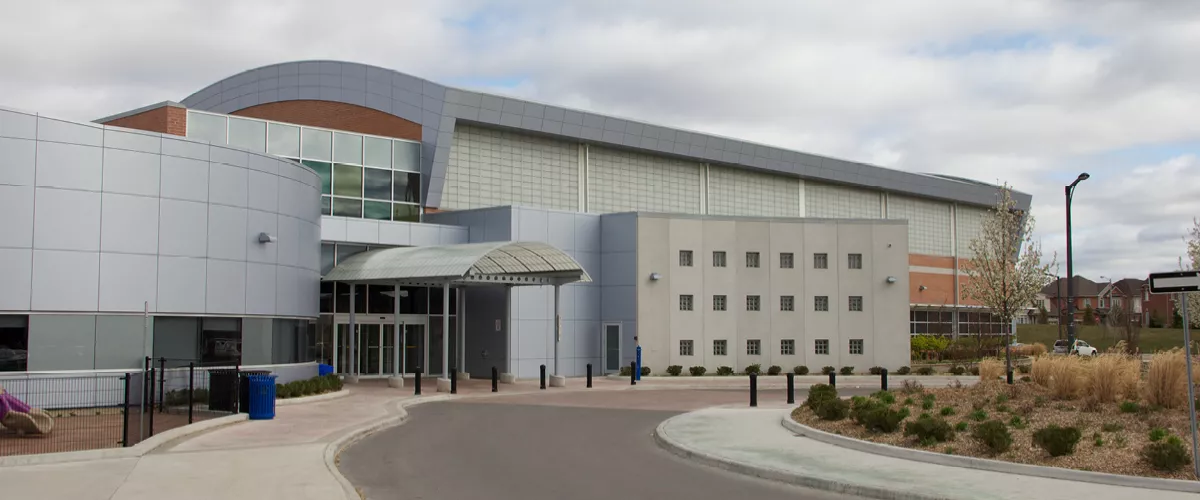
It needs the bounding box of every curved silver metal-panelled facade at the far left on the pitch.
[0,109,320,316]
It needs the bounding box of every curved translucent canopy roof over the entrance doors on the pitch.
[322,241,592,285]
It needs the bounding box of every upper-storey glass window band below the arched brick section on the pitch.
[187,110,421,222]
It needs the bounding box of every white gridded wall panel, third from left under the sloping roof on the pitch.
[708,165,804,217]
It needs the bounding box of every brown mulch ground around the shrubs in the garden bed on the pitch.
[792,381,1193,480]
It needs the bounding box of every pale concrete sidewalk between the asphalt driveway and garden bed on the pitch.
[655,408,1200,500]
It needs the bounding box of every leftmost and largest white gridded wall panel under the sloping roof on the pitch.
[442,125,580,211]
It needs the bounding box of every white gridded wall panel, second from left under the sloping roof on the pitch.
[588,146,703,213]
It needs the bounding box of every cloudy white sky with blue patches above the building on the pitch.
[0,0,1200,279]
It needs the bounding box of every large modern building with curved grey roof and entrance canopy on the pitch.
[0,61,1030,378]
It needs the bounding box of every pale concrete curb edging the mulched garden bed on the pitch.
[780,411,1200,493]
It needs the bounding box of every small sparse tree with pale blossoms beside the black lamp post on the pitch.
[962,183,1054,378]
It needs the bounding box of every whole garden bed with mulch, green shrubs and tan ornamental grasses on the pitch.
[792,350,1200,480]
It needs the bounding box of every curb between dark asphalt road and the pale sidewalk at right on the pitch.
[654,414,950,500]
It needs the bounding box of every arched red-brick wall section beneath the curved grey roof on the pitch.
[230,101,421,140]
